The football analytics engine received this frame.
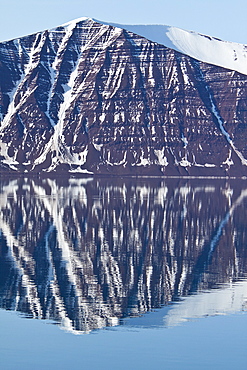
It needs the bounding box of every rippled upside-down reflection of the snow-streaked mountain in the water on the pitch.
[0,179,247,333]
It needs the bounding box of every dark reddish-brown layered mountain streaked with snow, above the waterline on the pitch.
[0,18,247,177]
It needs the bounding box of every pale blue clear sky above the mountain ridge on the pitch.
[0,0,247,44]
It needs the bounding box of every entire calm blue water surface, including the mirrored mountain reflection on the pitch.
[0,179,247,369]
